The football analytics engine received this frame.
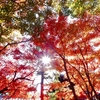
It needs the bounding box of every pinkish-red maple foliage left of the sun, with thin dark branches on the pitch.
[0,39,39,99]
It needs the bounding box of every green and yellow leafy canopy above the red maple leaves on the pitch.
[0,0,100,42]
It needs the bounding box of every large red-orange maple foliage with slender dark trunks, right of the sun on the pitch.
[34,14,100,100]
